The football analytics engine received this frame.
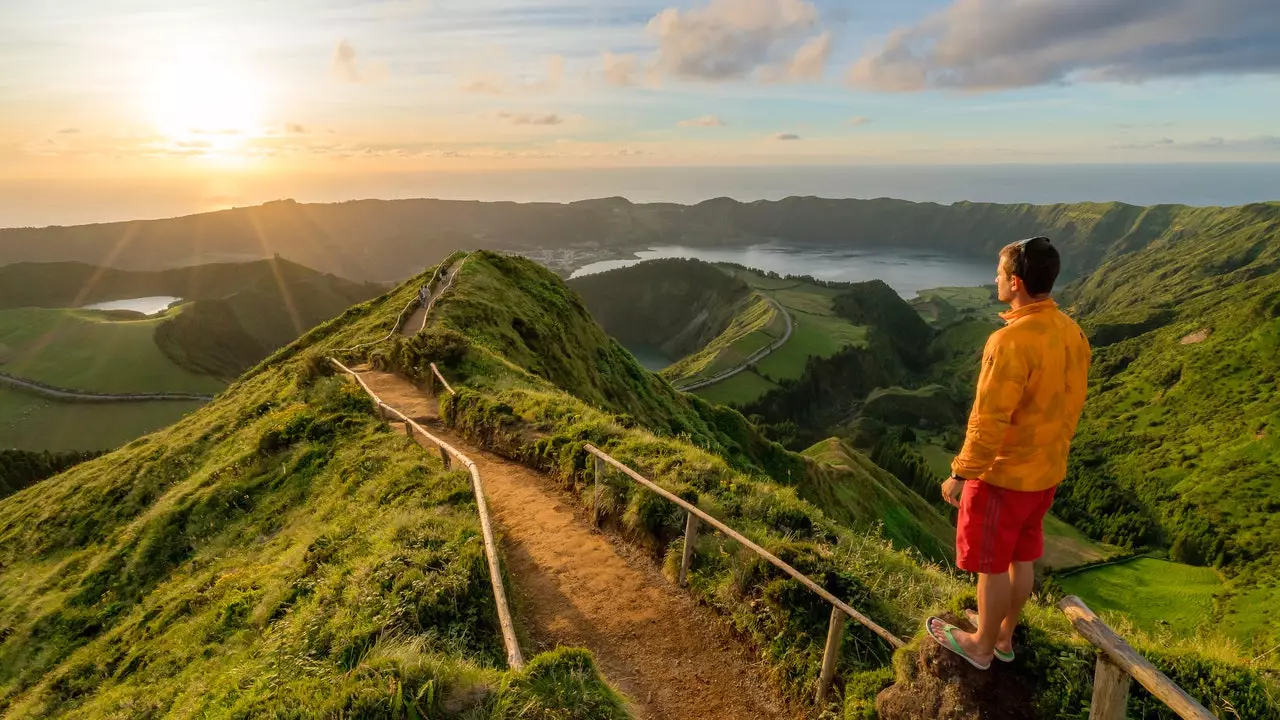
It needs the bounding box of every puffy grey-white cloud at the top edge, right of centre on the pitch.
[646,0,831,82]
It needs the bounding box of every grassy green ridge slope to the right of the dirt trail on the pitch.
[371,252,1280,717]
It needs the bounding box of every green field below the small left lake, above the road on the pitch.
[0,307,224,393]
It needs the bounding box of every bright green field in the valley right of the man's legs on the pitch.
[1059,557,1222,637]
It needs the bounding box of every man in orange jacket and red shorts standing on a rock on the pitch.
[925,237,1089,670]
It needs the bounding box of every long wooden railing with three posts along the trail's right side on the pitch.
[584,445,905,707]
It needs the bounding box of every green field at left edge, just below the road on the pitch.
[0,387,204,451]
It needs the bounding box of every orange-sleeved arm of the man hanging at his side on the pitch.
[951,332,1030,479]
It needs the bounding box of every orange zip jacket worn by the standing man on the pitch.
[951,300,1089,491]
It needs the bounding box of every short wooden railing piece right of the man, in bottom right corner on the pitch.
[1057,594,1216,720]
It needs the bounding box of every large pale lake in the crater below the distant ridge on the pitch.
[570,242,996,299]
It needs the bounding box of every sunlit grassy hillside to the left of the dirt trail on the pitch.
[0,258,625,720]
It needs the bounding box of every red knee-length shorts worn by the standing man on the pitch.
[956,480,1057,574]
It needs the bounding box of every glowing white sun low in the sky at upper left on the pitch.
[146,51,261,154]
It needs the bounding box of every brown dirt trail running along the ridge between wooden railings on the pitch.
[357,368,800,720]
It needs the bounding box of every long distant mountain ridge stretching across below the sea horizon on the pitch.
[0,197,1280,281]
